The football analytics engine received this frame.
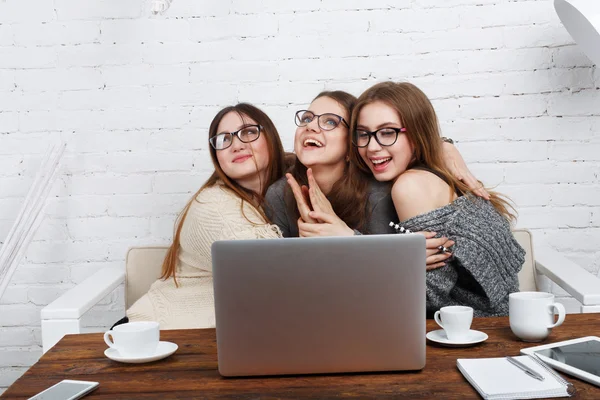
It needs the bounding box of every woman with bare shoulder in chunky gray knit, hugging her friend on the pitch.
[350,82,525,317]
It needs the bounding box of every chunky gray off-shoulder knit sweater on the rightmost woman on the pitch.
[400,195,525,317]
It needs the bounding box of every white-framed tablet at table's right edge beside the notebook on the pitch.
[521,336,600,386]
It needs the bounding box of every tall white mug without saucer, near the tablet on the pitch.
[508,292,565,342]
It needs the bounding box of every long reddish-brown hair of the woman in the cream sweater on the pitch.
[160,103,285,285]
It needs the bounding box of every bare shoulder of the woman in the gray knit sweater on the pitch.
[392,170,449,220]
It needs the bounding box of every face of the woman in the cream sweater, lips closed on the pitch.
[216,111,269,193]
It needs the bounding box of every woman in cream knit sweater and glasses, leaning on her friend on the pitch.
[127,104,285,329]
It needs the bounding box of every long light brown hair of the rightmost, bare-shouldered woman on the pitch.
[350,82,515,221]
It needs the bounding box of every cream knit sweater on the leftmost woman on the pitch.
[127,184,282,329]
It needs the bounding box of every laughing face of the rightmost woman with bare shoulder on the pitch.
[357,101,414,182]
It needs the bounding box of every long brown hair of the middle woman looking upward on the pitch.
[284,90,369,230]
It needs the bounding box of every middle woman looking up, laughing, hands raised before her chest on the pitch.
[265,91,487,267]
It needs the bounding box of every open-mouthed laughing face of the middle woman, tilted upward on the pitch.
[294,96,349,168]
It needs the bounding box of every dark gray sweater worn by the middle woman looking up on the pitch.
[265,177,398,237]
